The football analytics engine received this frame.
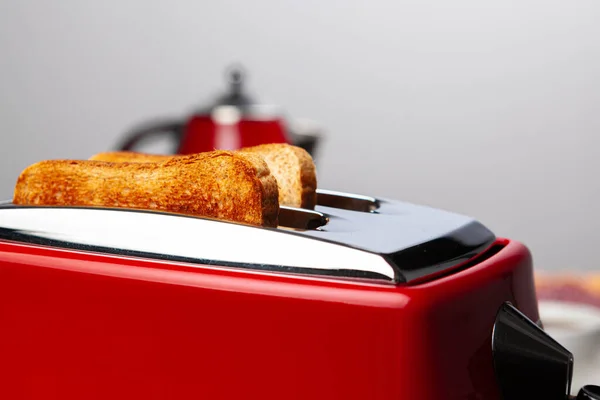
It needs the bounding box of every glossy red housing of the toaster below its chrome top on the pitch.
[0,240,538,400]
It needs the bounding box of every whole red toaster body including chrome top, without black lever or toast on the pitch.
[0,191,539,400]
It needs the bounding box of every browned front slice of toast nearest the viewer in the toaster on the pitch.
[13,151,279,227]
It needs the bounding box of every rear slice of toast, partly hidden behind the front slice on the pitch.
[90,144,317,209]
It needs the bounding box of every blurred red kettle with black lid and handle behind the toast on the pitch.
[118,66,320,156]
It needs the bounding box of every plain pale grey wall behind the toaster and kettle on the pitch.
[0,0,600,270]
